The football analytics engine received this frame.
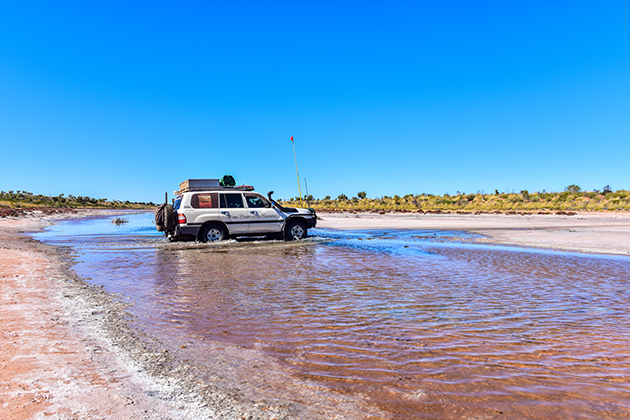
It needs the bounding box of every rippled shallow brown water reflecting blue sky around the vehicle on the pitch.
[34,214,630,419]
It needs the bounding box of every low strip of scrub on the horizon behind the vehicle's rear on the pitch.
[0,190,155,209]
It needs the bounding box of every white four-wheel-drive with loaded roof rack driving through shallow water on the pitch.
[155,180,317,242]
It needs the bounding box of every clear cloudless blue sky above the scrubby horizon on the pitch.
[0,0,630,202]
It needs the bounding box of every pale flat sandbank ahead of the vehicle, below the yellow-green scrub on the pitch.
[317,213,630,255]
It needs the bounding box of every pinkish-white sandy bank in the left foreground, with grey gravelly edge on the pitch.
[0,211,295,420]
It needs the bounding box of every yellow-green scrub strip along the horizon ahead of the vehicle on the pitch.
[284,184,630,214]
